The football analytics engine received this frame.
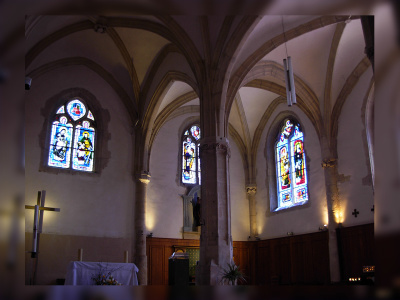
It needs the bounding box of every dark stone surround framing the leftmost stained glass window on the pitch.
[39,88,110,176]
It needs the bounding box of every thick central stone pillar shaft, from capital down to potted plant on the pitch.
[196,137,233,285]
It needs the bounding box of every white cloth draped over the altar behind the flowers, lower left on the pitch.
[65,261,139,285]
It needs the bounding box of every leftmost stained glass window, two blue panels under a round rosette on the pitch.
[48,99,96,172]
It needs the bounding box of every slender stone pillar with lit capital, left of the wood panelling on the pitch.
[134,171,150,285]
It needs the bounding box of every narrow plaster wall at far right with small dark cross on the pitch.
[338,68,374,226]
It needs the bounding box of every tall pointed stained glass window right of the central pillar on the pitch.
[275,119,308,210]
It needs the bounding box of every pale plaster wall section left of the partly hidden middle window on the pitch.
[146,114,191,238]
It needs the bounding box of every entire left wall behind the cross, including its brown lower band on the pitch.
[25,66,135,284]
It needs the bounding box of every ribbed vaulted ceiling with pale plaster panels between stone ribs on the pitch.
[25,3,380,162]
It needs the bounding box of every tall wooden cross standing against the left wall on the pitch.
[25,191,60,284]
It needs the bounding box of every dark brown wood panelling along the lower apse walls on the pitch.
[147,224,374,285]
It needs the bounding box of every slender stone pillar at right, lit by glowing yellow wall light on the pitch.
[322,158,341,282]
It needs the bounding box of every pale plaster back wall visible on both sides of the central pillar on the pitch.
[146,114,250,241]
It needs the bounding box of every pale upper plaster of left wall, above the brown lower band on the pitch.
[25,66,134,238]
